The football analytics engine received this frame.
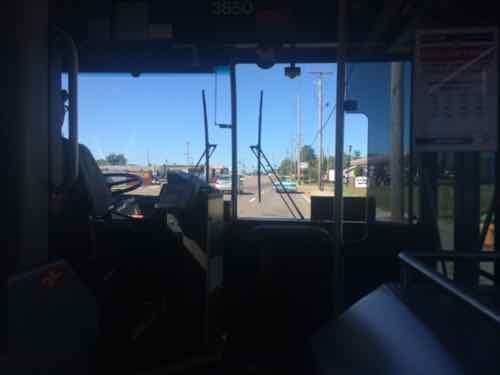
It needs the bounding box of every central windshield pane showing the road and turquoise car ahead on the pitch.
[236,64,336,219]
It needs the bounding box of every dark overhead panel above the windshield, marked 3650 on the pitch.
[50,0,497,71]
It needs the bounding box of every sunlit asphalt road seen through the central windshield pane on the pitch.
[238,176,311,219]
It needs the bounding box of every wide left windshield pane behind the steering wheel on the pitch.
[63,73,231,200]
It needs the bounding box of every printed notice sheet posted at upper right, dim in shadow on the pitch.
[413,28,498,151]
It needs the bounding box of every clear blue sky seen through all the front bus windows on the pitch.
[62,64,408,169]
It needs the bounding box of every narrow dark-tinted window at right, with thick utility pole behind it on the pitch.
[345,62,416,222]
